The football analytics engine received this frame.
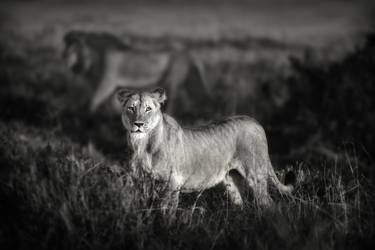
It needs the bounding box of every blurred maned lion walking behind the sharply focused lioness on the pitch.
[63,31,211,116]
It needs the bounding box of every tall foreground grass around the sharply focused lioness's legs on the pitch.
[0,119,374,249]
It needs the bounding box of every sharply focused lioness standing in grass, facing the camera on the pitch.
[117,88,293,206]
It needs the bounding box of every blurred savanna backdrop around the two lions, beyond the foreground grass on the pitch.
[0,0,375,248]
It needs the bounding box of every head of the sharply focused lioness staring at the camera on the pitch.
[117,88,167,138]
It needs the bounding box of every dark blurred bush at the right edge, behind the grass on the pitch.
[273,35,375,161]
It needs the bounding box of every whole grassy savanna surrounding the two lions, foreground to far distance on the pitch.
[0,1,375,249]
